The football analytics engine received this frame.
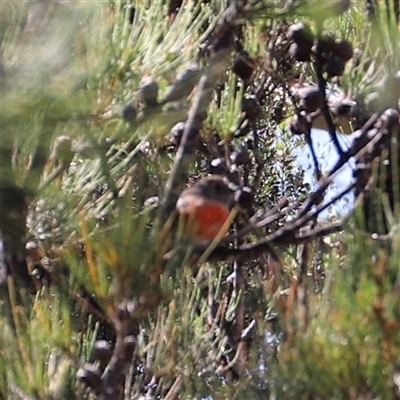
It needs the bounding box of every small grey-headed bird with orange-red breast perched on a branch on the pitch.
[176,175,234,242]
